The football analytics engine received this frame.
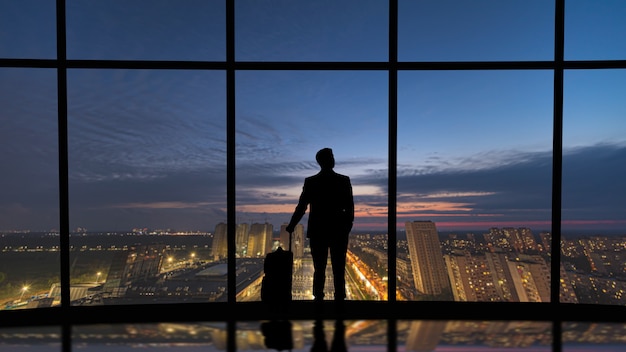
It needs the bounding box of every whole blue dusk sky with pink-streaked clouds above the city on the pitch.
[0,0,626,232]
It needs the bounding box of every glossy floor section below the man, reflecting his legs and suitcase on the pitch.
[236,320,388,352]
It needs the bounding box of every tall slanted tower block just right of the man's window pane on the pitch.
[405,221,451,295]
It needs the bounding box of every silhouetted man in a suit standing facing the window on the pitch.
[287,148,354,302]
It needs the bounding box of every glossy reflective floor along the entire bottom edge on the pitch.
[0,320,626,352]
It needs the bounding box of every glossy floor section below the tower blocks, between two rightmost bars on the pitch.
[398,320,552,352]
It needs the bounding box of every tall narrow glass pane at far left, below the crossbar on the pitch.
[0,68,60,309]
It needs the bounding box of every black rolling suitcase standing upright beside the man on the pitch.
[261,233,293,306]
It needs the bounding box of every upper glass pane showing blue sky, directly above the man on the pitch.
[235,0,389,61]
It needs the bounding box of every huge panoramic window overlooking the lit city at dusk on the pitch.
[0,0,626,328]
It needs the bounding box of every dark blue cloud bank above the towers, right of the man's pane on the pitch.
[390,145,626,230]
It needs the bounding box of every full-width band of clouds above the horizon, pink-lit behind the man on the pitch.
[0,135,626,234]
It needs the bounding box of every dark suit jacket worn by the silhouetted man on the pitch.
[289,170,354,237]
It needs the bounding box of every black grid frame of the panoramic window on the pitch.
[0,0,626,351]
